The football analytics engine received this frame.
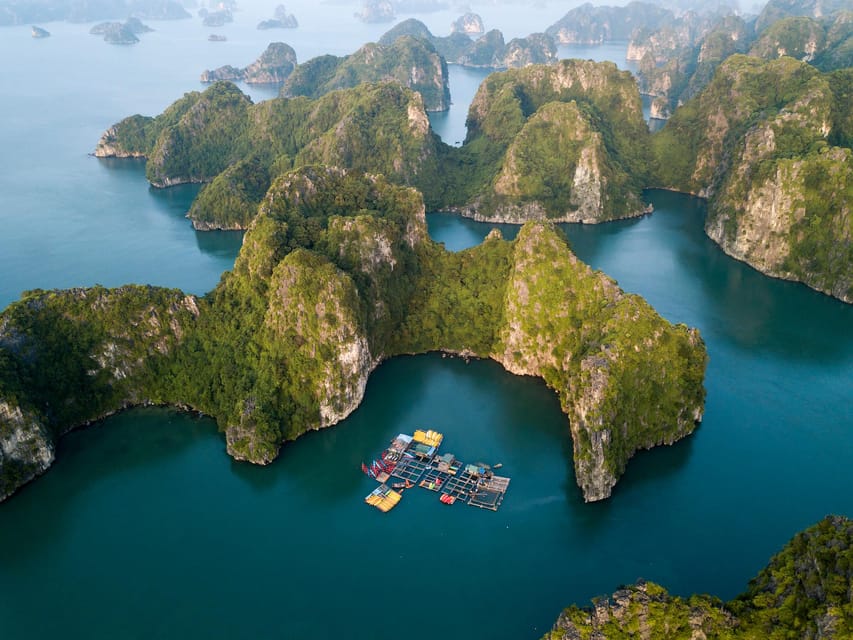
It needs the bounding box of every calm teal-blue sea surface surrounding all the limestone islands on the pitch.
[0,3,853,639]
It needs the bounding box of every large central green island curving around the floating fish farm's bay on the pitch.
[0,166,706,500]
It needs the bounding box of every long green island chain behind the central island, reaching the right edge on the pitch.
[95,45,853,302]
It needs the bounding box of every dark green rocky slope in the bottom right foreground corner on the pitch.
[543,516,853,640]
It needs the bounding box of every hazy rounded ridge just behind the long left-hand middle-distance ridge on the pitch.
[282,36,450,111]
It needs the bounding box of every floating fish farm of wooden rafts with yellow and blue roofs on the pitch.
[363,431,510,511]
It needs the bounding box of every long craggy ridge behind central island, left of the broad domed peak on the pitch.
[95,82,447,218]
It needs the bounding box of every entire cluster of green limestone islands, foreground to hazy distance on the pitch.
[0,0,853,639]
